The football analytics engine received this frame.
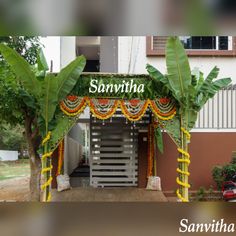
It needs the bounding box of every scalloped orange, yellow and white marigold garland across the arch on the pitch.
[60,95,176,121]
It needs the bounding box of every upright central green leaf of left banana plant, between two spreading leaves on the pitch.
[39,74,58,124]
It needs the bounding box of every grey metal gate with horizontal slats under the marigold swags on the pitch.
[90,111,148,187]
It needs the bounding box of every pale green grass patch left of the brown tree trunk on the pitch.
[0,159,30,181]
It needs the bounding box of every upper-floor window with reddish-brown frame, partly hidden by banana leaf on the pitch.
[147,36,236,56]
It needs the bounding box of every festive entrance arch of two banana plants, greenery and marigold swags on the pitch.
[0,37,231,202]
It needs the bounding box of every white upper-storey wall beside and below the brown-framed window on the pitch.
[118,36,236,83]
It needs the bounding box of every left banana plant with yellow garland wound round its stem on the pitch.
[0,44,86,201]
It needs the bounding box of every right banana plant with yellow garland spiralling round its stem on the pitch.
[146,37,231,202]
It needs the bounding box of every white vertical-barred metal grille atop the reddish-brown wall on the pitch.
[195,85,236,129]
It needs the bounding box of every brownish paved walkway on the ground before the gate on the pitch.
[52,187,167,202]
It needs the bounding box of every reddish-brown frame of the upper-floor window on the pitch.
[146,36,236,57]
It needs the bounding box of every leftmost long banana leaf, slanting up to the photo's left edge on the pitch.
[0,44,40,96]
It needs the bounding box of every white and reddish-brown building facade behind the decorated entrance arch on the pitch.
[43,36,236,191]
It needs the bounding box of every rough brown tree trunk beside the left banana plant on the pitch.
[25,116,41,201]
